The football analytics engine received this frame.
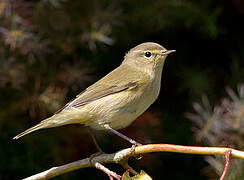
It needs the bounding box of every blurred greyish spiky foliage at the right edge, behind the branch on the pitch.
[186,84,244,179]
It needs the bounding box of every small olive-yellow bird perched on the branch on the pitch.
[13,42,175,144]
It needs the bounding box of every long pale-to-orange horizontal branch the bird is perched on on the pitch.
[24,144,244,180]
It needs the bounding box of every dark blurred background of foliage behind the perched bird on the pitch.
[0,0,244,180]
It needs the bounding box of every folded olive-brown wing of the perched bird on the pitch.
[55,64,141,114]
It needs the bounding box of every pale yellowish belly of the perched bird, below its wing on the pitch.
[86,91,156,130]
